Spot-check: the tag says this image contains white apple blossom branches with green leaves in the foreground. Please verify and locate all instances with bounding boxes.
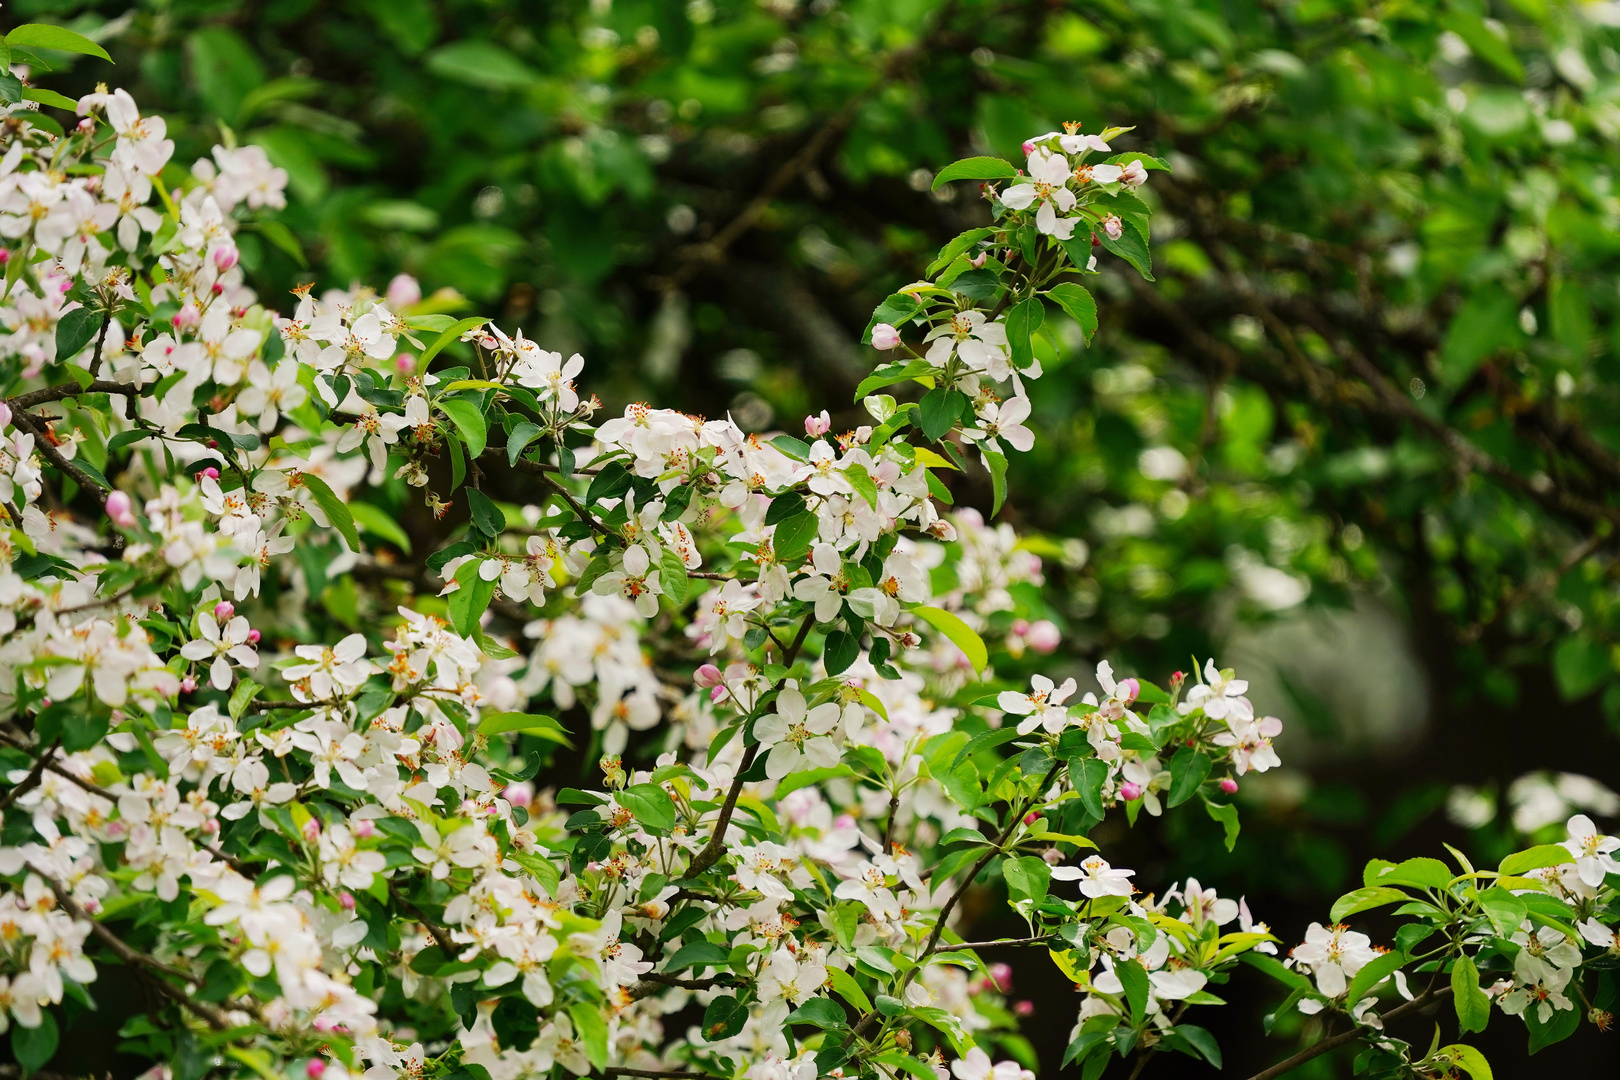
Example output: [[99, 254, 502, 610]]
[[0, 23, 1620, 1080]]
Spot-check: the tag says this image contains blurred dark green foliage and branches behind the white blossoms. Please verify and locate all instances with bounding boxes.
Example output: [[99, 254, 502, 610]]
[[9, 0, 1620, 1077]]
